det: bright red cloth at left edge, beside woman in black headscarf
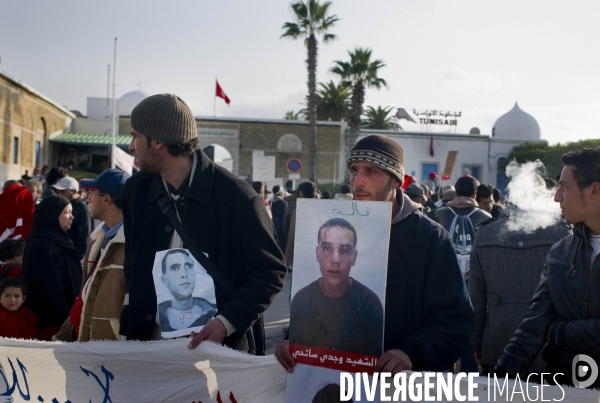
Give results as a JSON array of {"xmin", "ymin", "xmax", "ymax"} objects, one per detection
[{"xmin": 0, "ymin": 184, "xmax": 34, "ymax": 242}]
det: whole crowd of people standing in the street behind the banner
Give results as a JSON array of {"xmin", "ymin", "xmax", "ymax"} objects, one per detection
[{"xmin": 0, "ymin": 94, "xmax": 600, "ymax": 386}]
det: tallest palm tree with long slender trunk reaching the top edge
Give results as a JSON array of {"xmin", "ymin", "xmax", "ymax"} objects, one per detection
[{"xmin": 281, "ymin": 0, "xmax": 339, "ymax": 182}]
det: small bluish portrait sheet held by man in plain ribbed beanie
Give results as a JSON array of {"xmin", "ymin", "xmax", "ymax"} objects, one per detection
[{"xmin": 152, "ymin": 249, "xmax": 217, "ymax": 338}]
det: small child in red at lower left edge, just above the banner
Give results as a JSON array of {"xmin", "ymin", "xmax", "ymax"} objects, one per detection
[{"xmin": 0, "ymin": 277, "xmax": 39, "ymax": 339}]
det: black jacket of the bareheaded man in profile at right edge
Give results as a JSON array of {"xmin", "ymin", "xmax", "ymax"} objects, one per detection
[{"xmin": 498, "ymin": 223, "xmax": 600, "ymax": 379}]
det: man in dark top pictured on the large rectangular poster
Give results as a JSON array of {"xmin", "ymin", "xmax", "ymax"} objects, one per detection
[{"xmin": 290, "ymin": 218, "xmax": 383, "ymax": 356}]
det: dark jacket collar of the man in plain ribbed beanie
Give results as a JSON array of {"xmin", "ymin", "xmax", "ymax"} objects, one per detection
[{"xmin": 148, "ymin": 150, "xmax": 215, "ymax": 204}]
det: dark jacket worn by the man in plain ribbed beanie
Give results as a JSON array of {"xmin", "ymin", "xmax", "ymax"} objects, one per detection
[{"xmin": 120, "ymin": 151, "xmax": 286, "ymax": 354}]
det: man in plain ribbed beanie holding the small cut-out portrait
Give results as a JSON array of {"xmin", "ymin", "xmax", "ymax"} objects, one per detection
[{"xmin": 120, "ymin": 94, "xmax": 286, "ymax": 355}]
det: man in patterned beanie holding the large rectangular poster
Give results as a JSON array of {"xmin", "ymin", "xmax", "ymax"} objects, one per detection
[{"xmin": 275, "ymin": 134, "xmax": 474, "ymax": 374}]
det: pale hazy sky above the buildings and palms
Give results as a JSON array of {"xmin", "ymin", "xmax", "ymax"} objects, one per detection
[{"xmin": 0, "ymin": 0, "xmax": 600, "ymax": 144}]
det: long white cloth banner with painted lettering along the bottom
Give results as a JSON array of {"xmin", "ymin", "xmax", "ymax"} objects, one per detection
[{"xmin": 0, "ymin": 338, "xmax": 600, "ymax": 403}]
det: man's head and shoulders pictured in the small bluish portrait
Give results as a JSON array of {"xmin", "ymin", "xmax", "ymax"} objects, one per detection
[{"xmin": 158, "ymin": 249, "xmax": 217, "ymax": 332}]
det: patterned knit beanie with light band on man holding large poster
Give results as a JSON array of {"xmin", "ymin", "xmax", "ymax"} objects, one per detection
[{"xmin": 346, "ymin": 134, "xmax": 404, "ymax": 184}]
